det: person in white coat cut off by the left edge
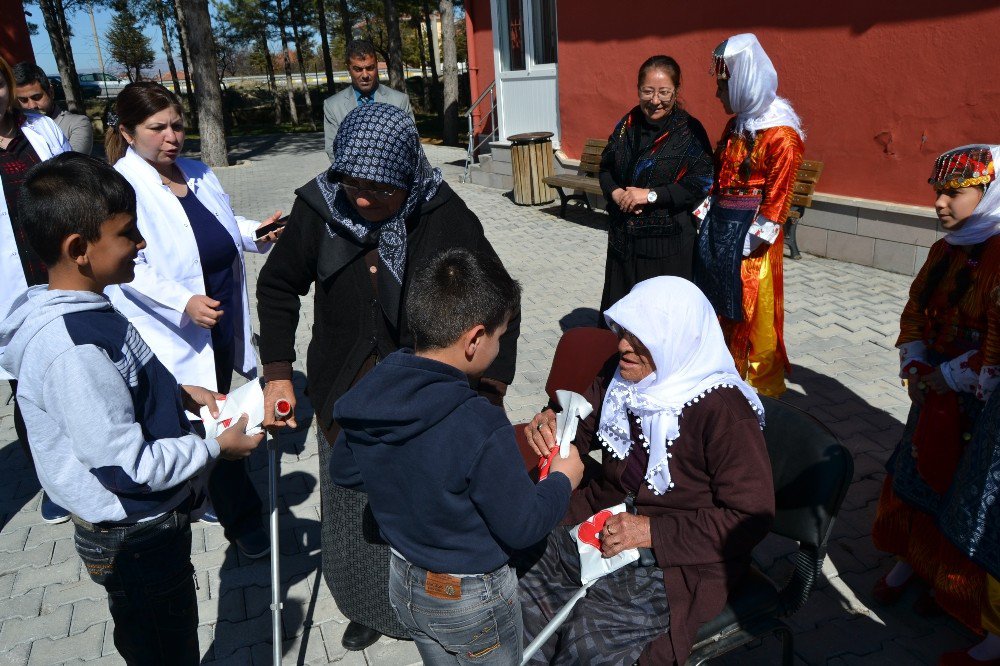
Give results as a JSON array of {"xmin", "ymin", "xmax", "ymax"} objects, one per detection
[{"xmin": 0, "ymin": 58, "xmax": 71, "ymax": 523}]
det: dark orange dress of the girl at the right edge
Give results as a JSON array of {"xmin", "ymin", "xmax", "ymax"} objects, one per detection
[{"xmin": 872, "ymin": 236, "xmax": 1000, "ymax": 632}]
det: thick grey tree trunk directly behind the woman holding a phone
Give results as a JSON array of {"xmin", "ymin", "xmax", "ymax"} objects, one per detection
[{"xmin": 179, "ymin": 0, "xmax": 229, "ymax": 167}]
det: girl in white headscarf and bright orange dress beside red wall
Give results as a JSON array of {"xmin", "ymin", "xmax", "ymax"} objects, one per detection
[{"xmin": 695, "ymin": 33, "xmax": 805, "ymax": 397}]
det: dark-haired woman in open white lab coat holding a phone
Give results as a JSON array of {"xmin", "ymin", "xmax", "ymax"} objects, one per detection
[{"xmin": 105, "ymin": 82, "xmax": 281, "ymax": 557}]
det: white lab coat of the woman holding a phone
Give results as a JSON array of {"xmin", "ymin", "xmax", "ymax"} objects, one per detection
[{"xmin": 106, "ymin": 148, "xmax": 270, "ymax": 390}]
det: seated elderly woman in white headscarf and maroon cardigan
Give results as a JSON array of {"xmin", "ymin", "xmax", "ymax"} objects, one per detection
[{"xmin": 520, "ymin": 277, "xmax": 774, "ymax": 664}]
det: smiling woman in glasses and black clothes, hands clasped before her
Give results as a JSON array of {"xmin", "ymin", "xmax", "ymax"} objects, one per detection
[{"xmin": 600, "ymin": 55, "xmax": 713, "ymax": 312}]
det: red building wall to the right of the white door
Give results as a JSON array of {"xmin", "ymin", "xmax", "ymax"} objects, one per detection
[{"xmin": 556, "ymin": 0, "xmax": 1000, "ymax": 205}]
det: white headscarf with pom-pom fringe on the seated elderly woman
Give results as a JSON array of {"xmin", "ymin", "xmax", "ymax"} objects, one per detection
[{"xmin": 597, "ymin": 277, "xmax": 764, "ymax": 494}]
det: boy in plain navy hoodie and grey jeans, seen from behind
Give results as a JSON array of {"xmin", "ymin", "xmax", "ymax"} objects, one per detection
[{"xmin": 330, "ymin": 249, "xmax": 583, "ymax": 664}]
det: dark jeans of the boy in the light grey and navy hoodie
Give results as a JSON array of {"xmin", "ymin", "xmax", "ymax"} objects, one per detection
[{"xmin": 74, "ymin": 509, "xmax": 201, "ymax": 666}]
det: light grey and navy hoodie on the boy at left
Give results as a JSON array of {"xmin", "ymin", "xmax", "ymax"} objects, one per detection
[{"xmin": 0, "ymin": 285, "xmax": 219, "ymax": 523}]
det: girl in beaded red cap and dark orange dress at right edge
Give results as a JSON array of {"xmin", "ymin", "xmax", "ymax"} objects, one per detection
[{"xmin": 872, "ymin": 145, "xmax": 1000, "ymax": 666}]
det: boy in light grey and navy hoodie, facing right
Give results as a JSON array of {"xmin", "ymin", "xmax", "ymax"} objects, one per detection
[{"xmin": 0, "ymin": 153, "xmax": 263, "ymax": 666}]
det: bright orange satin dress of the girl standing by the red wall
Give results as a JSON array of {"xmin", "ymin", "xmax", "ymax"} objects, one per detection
[{"xmin": 713, "ymin": 120, "xmax": 804, "ymax": 397}]
